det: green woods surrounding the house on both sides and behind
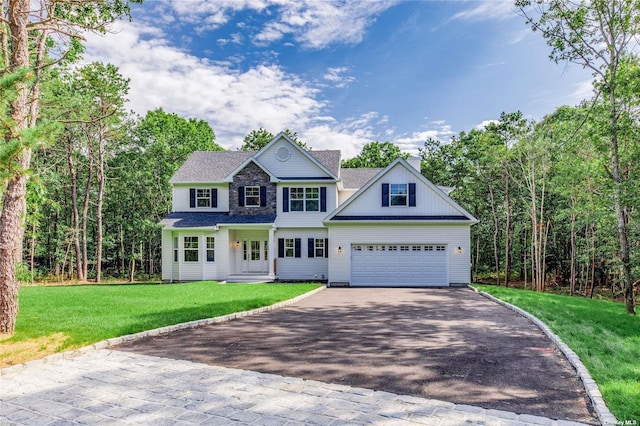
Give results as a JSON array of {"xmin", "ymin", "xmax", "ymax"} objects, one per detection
[{"xmin": 0, "ymin": 0, "xmax": 640, "ymax": 330}]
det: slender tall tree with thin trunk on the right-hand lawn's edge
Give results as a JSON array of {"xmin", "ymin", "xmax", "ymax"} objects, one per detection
[{"xmin": 516, "ymin": 0, "xmax": 640, "ymax": 314}]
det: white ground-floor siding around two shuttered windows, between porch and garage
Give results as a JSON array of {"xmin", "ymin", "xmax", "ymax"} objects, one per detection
[{"xmin": 274, "ymin": 229, "xmax": 331, "ymax": 281}]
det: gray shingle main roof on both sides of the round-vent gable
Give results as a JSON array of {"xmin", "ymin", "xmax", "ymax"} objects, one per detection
[{"xmin": 169, "ymin": 150, "xmax": 340, "ymax": 183}]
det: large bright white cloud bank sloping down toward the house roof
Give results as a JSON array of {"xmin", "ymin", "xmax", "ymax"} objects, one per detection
[{"xmin": 85, "ymin": 22, "xmax": 388, "ymax": 158}]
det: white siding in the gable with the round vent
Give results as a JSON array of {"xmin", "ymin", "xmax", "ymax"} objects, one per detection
[{"xmin": 257, "ymin": 139, "xmax": 331, "ymax": 178}]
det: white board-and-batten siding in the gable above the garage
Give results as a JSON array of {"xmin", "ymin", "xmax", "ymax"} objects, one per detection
[{"xmin": 340, "ymin": 164, "xmax": 460, "ymax": 216}]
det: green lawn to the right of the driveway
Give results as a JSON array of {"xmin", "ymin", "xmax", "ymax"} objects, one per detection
[{"xmin": 476, "ymin": 285, "xmax": 640, "ymax": 424}]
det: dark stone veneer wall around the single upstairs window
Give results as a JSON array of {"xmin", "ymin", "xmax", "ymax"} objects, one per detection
[{"xmin": 229, "ymin": 163, "xmax": 277, "ymax": 216}]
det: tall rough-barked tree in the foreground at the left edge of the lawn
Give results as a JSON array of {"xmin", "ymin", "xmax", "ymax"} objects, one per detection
[{"xmin": 0, "ymin": 0, "xmax": 140, "ymax": 334}]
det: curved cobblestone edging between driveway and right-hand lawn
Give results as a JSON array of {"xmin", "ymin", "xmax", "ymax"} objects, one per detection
[{"xmin": 469, "ymin": 285, "xmax": 619, "ymax": 425}]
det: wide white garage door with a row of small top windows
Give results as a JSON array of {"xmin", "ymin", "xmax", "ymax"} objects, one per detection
[{"xmin": 351, "ymin": 244, "xmax": 449, "ymax": 287}]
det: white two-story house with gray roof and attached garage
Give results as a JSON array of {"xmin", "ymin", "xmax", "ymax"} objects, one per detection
[{"xmin": 160, "ymin": 133, "xmax": 477, "ymax": 287}]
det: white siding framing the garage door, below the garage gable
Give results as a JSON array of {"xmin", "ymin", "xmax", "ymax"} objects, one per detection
[{"xmin": 328, "ymin": 223, "xmax": 471, "ymax": 284}]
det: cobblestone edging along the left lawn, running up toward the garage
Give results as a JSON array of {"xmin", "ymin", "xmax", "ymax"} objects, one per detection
[{"xmin": 0, "ymin": 286, "xmax": 326, "ymax": 377}]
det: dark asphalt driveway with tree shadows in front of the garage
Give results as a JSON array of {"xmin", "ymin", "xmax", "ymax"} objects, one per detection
[{"xmin": 116, "ymin": 288, "xmax": 597, "ymax": 423}]
